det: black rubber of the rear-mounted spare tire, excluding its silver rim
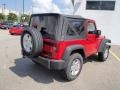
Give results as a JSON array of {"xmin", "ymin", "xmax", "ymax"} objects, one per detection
[{"xmin": 21, "ymin": 28, "xmax": 43, "ymax": 58}]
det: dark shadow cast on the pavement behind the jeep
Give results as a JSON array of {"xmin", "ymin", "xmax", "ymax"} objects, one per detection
[{"xmin": 10, "ymin": 58, "xmax": 66, "ymax": 84}]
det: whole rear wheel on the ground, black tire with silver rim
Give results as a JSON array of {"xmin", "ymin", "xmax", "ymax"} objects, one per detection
[{"xmin": 62, "ymin": 53, "xmax": 83, "ymax": 81}]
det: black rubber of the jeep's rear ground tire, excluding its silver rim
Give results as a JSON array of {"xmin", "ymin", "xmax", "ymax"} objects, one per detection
[{"xmin": 61, "ymin": 53, "xmax": 83, "ymax": 81}]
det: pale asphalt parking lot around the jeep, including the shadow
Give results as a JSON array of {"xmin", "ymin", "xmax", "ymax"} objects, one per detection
[{"xmin": 0, "ymin": 30, "xmax": 120, "ymax": 90}]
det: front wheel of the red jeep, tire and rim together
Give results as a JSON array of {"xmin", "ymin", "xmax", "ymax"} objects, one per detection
[{"xmin": 98, "ymin": 44, "xmax": 110, "ymax": 61}]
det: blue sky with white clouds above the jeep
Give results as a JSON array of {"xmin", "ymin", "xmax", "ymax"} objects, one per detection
[{"xmin": 0, "ymin": 0, "xmax": 73, "ymax": 14}]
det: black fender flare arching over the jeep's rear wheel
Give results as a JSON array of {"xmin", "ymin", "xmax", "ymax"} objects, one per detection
[{"xmin": 62, "ymin": 45, "xmax": 86, "ymax": 61}]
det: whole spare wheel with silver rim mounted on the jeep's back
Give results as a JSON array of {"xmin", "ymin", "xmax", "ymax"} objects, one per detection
[{"xmin": 21, "ymin": 28, "xmax": 43, "ymax": 58}]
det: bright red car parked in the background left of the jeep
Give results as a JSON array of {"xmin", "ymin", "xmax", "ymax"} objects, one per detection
[{"xmin": 9, "ymin": 25, "xmax": 27, "ymax": 35}]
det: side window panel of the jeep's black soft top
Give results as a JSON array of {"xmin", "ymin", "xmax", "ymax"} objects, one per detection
[{"xmin": 65, "ymin": 19, "xmax": 86, "ymax": 40}]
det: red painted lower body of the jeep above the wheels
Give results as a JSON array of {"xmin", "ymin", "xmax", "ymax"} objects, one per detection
[{"xmin": 43, "ymin": 37, "xmax": 104, "ymax": 60}]
